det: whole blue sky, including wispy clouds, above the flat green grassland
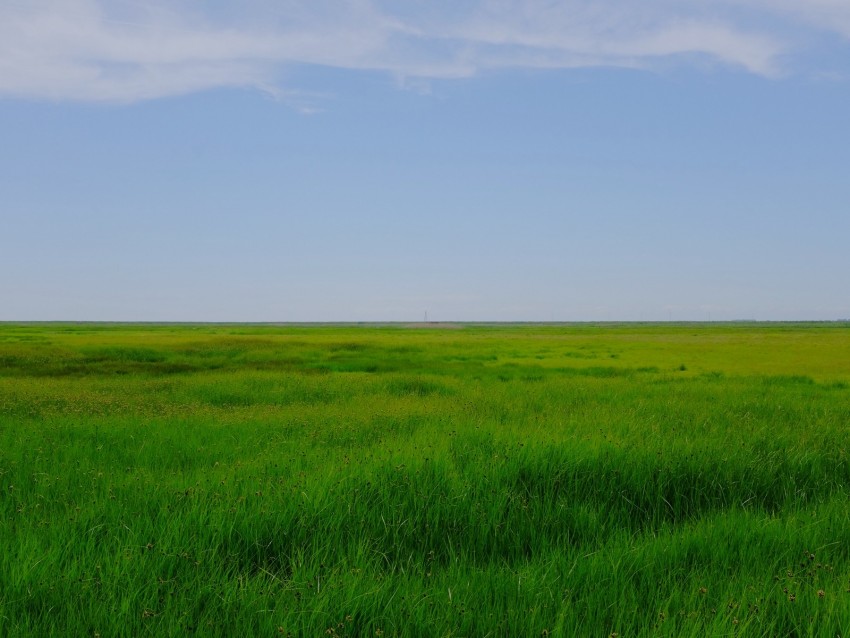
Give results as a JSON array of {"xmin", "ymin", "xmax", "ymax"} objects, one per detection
[{"xmin": 0, "ymin": 0, "xmax": 850, "ymax": 322}]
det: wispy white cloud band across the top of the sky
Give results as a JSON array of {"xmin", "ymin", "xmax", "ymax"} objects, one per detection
[{"xmin": 0, "ymin": 0, "xmax": 850, "ymax": 102}]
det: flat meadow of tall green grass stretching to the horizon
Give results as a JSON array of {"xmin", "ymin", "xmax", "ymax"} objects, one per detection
[{"xmin": 0, "ymin": 324, "xmax": 850, "ymax": 638}]
